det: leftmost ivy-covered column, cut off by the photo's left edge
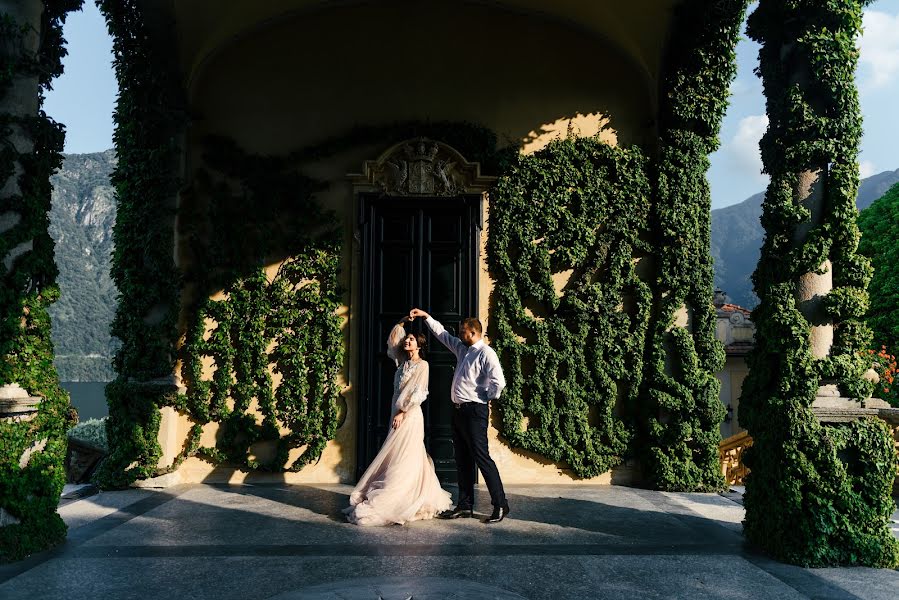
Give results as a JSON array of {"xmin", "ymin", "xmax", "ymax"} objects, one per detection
[{"xmin": 0, "ymin": 0, "xmax": 81, "ymax": 560}]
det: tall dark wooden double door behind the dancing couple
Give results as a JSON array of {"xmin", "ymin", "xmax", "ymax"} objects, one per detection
[{"xmin": 356, "ymin": 195, "xmax": 481, "ymax": 483}]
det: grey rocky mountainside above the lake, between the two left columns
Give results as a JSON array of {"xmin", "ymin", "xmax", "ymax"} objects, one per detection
[{"xmin": 50, "ymin": 150, "xmax": 117, "ymax": 381}]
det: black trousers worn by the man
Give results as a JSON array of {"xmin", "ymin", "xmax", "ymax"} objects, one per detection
[{"xmin": 453, "ymin": 402, "xmax": 507, "ymax": 508}]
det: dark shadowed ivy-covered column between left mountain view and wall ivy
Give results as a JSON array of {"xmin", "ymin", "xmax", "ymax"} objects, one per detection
[{"xmin": 96, "ymin": 0, "xmax": 182, "ymax": 487}]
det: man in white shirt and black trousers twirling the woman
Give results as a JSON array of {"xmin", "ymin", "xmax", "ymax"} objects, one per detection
[{"xmin": 409, "ymin": 308, "xmax": 509, "ymax": 523}]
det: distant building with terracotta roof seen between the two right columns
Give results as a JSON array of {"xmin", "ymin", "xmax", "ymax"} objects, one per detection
[{"xmin": 713, "ymin": 290, "xmax": 755, "ymax": 438}]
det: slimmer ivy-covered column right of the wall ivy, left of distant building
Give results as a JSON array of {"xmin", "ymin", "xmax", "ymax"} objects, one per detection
[{"xmin": 641, "ymin": 0, "xmax": 747, "ymax": 491}]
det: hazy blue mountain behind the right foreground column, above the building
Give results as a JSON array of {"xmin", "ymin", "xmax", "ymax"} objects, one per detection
[{"xmin": 712, "ymin": 169, "xmax": 899, "ymax": 309}]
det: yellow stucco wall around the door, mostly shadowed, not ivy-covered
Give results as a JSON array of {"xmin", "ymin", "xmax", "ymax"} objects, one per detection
[{"xmin": 160, "ymin": 3, "xmax": 655, "ymax": 483}]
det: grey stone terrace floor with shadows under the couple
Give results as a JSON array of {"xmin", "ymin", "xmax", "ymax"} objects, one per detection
[{"xmin": 0, "ymin": 484, "xmax": 899, "ymax": 600}]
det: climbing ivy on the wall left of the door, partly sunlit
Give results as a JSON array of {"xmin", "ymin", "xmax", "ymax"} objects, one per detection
[{"xmin": 171, "ymin": 139, "xmax": 343, "ymax": 471}]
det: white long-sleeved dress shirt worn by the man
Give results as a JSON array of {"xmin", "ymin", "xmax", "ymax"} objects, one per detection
[{"xmin": 425, "ymin": 317, "xmax": 506, "ymax": 404}]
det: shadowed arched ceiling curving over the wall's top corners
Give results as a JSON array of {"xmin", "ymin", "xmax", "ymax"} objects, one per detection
[{"xmin": 155, "ymin": 0, "xmax": 680, "ymax": 89}]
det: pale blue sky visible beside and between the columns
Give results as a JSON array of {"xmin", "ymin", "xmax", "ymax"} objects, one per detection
[{"xmin": 44, "ymin": 0, "xmax": 899, "ymax": 208}]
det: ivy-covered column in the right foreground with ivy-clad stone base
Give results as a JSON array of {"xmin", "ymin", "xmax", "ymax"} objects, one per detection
[{"xmin": 740, "ymin": 0, "xmax": 899, "ymax": 567}]
